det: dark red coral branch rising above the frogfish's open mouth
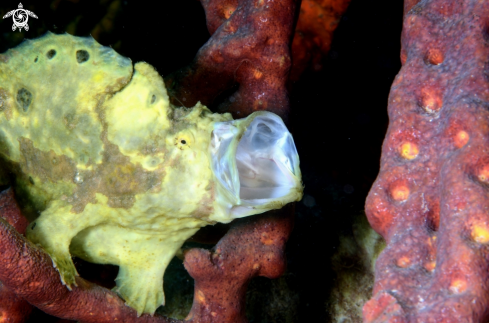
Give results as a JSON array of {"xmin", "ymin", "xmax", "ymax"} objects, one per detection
[{"xmin": 165, "ymin": 0, "xmax": 298, "ymax": 118}]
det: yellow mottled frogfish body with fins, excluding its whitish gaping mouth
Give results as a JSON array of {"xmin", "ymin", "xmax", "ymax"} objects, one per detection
[{"xmin": 0, "ymin": 33, "xmax": 302, "ymax": 314}]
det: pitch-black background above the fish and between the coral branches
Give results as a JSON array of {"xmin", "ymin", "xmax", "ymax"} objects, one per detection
[{"xmin": 0, "ymin": 0, "xmax": 403, "ymax": 322}]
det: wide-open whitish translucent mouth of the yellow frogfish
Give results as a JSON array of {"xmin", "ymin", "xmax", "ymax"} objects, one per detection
[{"xmin": 209, "ymin": 111, "xmax": 303, "ymax": 218}]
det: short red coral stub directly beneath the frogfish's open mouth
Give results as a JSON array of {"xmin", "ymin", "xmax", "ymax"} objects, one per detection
[{"xmin": 184, "ymin": 205, "xmax": 294, "ymax": 323}]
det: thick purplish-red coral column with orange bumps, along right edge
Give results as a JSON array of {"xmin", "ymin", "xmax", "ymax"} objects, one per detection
[{"xmin": 363, "ymin": 0, "xmax": 489, "ymax": 322}]
